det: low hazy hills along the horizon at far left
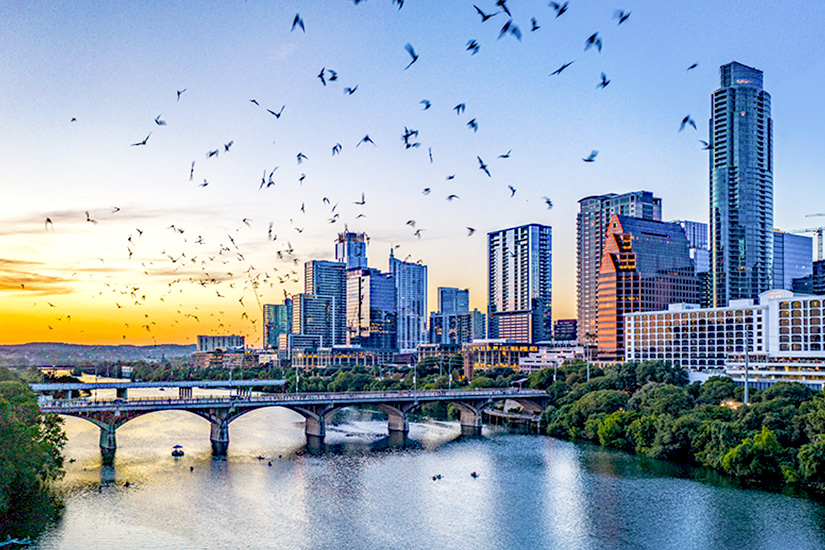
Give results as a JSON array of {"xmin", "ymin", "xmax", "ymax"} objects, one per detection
[{"xmin": 0, "ymin": 342, "xmax": 197, "ymax": 366}]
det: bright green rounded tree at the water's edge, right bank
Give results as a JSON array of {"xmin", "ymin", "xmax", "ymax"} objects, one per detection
[{"xmin": 722, "ymin": 426, "xmax": 783, "ymax": 481}]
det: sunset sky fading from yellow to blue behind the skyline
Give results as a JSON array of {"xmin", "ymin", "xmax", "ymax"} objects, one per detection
[{"xmin": 0, "ymin": 0, "xmax": 825, "ymax": 345}]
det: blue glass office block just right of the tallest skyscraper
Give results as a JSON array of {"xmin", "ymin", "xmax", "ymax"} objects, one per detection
[{"xmin": 773, "ymin": 230, "xmax": 814, "ymax": 294}]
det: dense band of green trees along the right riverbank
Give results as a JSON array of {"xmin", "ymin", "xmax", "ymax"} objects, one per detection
[{"xmin": 530, "ymin": 361, "xmax": 825, "ymax": 494}]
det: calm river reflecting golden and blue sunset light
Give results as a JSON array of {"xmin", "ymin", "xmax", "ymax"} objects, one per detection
[{"xmin": 20, "ymin": 390, "xmax": 825, "ymax": 550}]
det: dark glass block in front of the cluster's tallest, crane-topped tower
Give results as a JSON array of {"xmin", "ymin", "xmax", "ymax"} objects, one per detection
[{"xmin": 347, "ymin": 268, "xmax": 397, "ymax": 351}]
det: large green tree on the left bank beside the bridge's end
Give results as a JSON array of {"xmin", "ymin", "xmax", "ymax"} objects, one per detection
[{"xmin": 0, "ymin": 381, "xmax": 66, "ymax": 513}]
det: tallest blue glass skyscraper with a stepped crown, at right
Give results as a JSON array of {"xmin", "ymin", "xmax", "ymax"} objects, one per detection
[{"xmin": 709, "ymin": 61, "xmax": 773, "ymax": 307}]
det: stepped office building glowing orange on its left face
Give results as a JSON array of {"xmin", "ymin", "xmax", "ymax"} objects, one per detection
[{"xmin": 596, "ymin": 215, "xmax": 700, "ymax": 362}]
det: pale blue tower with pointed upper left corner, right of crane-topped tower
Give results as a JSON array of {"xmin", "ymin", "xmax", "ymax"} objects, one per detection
[{"xmin": 389, "ymin": 249, "xmax": 427, "ymax": 353}]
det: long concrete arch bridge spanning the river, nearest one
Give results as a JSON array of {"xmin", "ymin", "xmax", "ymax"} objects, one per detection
[{"xmin": 33, "ymin": 381, "xmax": 548, "ymax": 463}]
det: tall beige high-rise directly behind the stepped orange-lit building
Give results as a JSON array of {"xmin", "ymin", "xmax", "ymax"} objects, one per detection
[{"xmin": 576, "ymin": 191, "xmax": 662, "ymax": 343}]
